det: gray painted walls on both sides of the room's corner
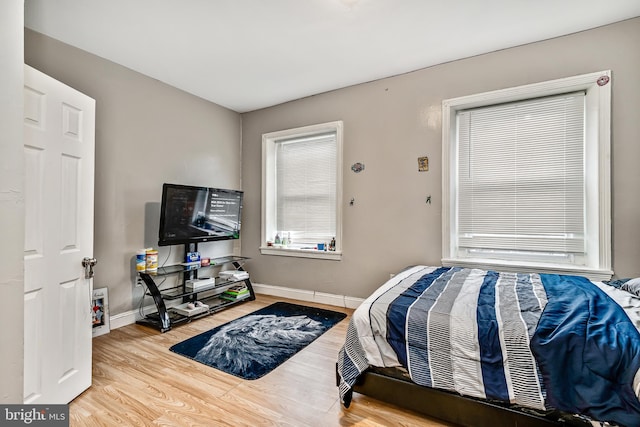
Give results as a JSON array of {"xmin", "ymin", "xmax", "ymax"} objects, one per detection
[{"xmin": 25, "ymin": 18, "xmax": 640, "ymax": 314}]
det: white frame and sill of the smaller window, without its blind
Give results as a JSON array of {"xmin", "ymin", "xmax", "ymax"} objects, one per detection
[{"xmin": 260, "ymin": 121, "xmax": 344, "ymax": 260}]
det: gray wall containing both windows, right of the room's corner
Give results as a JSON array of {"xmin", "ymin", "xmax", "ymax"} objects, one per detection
[{"xmin": 242, "ymin": 18, "xmax": 640, "ymax": 297}]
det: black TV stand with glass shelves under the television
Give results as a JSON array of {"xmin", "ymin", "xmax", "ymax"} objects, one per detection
[{"xmin": 136, "ymin": 247, "xmax": 256, "ymax": 332}]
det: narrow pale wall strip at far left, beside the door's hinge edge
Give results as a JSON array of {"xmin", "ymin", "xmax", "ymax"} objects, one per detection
[{"xmin": 0, "ymin": 0, "xmax": 24, "ymax": 404}]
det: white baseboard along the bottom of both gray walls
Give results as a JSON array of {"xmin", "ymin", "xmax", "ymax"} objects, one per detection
[{"xmin": 109, "ymin": 283, "xmax": 364, "ymax": 329}]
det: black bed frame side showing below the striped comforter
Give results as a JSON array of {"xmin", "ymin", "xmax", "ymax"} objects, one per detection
[{"xmin": 342, "ymin": 371, "xmax": 591, "ymax": 427}]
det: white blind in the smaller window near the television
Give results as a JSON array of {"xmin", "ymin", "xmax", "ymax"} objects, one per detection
[{"xmin": 275, "ymin": 132, "xmax": 337, "ymax": 244}]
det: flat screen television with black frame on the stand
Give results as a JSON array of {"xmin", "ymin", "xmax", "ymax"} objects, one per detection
[{"xmin": 158, "ymin": 183, "xmax": 243, "ymax": 246}]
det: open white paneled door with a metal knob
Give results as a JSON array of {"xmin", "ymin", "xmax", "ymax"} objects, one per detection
[{"xmin": 24, "ymin": 65, "xmax": 95, "ymax": 404}]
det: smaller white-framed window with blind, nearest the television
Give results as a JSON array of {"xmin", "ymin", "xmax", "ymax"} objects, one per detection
[{"xmin": 260, "ymin": 121, "xmax": 342, "ymax": 259}]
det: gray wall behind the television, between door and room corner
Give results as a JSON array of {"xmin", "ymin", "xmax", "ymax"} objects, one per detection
[{"xmin": 25, "ymin": 29, "xmax": 241, "ymax": 316}]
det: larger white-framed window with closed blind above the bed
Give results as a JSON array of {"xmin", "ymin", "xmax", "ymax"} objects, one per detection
[{"xmin": 443, "ymin": 71, "xmax": 612, "ymax": 280}]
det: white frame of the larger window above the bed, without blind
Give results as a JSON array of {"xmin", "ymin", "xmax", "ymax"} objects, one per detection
[{"xmin": 442, "ymin": 70, "xmax": 613, "ymax": 280}]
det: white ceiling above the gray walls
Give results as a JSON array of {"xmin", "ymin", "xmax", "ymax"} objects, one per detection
[{"xmin": 25, "ymin": 0, "xmax": 640, "ymax": 112}]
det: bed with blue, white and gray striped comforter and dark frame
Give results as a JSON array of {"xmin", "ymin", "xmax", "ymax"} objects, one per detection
[{"xmin": 337, "ymin": 266, "xmax": 640, "ymax": 427}]
